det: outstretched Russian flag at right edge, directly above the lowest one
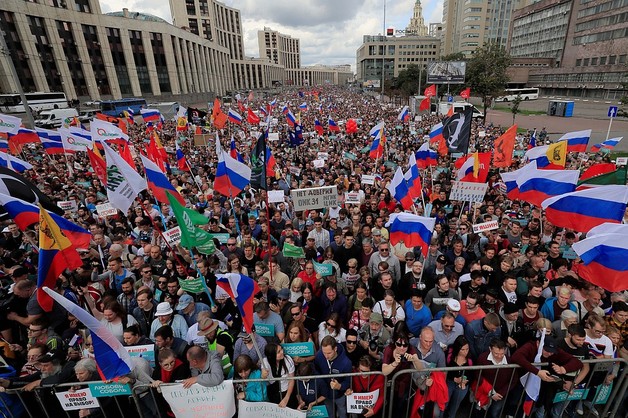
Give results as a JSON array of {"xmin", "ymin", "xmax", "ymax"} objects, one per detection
[{"xmin": 542, "ymin": 185, "xmax": 628, "ymax": 232}]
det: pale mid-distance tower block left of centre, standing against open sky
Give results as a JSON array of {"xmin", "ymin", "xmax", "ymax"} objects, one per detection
[{"xmin": 257, "ymin": 27, "xmax": 301, "ymax": 69}]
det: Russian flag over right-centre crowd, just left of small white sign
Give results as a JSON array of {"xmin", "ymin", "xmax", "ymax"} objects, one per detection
[{"xmin": 386, "ymin": 213, "xmax": 436, "ymax": 257}]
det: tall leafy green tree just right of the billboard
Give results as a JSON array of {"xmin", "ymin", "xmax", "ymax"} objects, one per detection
[{"xmin": 466, "ymin": 43, "xmax": 512, "ymax": 119}]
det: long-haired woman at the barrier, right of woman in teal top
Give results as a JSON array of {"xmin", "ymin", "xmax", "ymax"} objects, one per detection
[{"xmin": 262, "ymin": 343, "xmax": 297, "ymax": 408}]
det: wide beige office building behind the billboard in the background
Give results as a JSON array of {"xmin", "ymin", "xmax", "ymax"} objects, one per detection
[{"xmin": 356, "ymin": 35, "xmax": 440, "ymax": 83}]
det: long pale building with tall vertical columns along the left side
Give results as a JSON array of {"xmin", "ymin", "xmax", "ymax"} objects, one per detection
[{"xmin": 0, "ymin": 0, "xmax": 354, "ymax": 103}]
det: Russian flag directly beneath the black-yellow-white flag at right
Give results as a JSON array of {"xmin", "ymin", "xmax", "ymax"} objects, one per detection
[{"xmin": 506, "ymin": 161, "xmax": 580, "ymax": 207}]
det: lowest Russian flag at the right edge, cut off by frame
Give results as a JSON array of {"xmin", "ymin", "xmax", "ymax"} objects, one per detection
[{"xmin": 572, "ymin": 230, "xmax": 628, "ymax": 292}]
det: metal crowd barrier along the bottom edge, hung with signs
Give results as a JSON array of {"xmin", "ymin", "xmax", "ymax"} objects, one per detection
[{"xmin": 0, "ymin": 359, "xmax": 628, "ymax": 418}]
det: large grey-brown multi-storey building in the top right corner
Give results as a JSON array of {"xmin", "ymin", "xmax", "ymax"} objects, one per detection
[{"xmin": 510, "ymin": 0, "xmax": 628, "ymax": 100}]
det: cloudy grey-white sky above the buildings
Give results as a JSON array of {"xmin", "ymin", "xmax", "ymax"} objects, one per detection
[{"xmin": 100, "ymin": 0, "xmax": 443, "ymax": 68}]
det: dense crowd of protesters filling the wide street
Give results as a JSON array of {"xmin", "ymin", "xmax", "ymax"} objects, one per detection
[{"xmin": 0, "ymin": 87, "xmax": 628, "ymax": 418}]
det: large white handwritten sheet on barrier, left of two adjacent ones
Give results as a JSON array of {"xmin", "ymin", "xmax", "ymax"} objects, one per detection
[{"xmin": 160, "ymin": 380, "xmax": 235, "ymax": 418}]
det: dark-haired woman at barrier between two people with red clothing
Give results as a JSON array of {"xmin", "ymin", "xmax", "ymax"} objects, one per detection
[{"xmin": 445, "ymin": 335, "xmax": 473, "ymax": 418}]
